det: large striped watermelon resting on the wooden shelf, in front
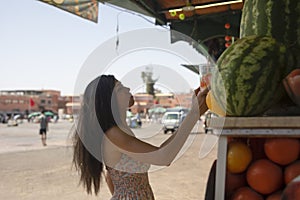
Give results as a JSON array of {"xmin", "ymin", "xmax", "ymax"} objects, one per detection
[{"xmin": 211, "ymin": 35, "xmax": 293, "ymax": 116}]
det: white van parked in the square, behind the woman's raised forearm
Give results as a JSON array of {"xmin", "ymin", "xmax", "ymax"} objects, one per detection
[{"xmin": 161, "ymin": 112, "xmax": 184, "ymax": 134}]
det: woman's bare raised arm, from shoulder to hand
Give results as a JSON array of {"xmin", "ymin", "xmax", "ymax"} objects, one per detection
[{"xmin": 105, "ymin": 89, "xmax": 208, "ymax": 166}]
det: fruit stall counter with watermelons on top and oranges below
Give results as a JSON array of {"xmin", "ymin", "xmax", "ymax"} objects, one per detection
[{"xmin": 207, "ymin": 0, "xmax": 300, "ymax": 200}]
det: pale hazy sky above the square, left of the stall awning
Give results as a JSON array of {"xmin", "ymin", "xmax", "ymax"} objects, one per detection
[{"xmin": 0, "ymin": 0, "xmax": 207, "ymax": 95}]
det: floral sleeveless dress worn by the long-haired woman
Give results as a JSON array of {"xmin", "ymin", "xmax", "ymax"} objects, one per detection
[{"xmin": 106, "ymin": 154, "xmax": 154, "ymax": 200}]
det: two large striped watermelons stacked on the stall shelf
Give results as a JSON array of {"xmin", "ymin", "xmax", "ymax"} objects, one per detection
[{"xmin": 211, "ymin": 0, "xmax": 300, "ymax": 116}]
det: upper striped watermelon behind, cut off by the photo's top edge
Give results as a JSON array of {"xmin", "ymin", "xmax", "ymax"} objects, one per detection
[{"xmin": 240, "ymin": 0, "xmax": 300, "ymax": 68}]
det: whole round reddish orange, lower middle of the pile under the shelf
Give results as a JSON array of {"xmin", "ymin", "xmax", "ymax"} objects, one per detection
[{"xmin": 247, "ymin": 159, "xmax": 283, "ymax": 194}]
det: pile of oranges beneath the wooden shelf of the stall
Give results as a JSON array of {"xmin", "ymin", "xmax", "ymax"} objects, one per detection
[{"xmin": 225, "ymin": 138, "xmax": 300, "ymax": 200}]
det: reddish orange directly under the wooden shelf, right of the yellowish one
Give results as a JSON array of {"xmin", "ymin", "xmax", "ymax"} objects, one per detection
[{"xmin": 264, "ymin": 138, "xmax": 300, "ymax": 165}]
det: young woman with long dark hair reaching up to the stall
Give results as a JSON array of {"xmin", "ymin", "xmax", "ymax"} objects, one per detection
[{"xmin": 73, "ymin": 75, "xmax": 208, "ymax": 200}]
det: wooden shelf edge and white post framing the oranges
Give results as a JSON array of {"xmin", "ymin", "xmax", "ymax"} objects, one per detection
[{"xmin": 209, "ymin": 116, "xmax": 300, "ymax": 200}]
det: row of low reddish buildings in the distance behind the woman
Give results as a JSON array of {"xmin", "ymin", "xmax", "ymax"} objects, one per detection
[{"xmin": 0, "ymin": 90, "xmax": 192, "ymax": 115}]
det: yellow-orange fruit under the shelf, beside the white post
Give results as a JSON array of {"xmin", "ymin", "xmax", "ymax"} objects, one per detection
[{"xmin": 227, "ymin": 141, "xmax": 252, "ymax": 173}]
